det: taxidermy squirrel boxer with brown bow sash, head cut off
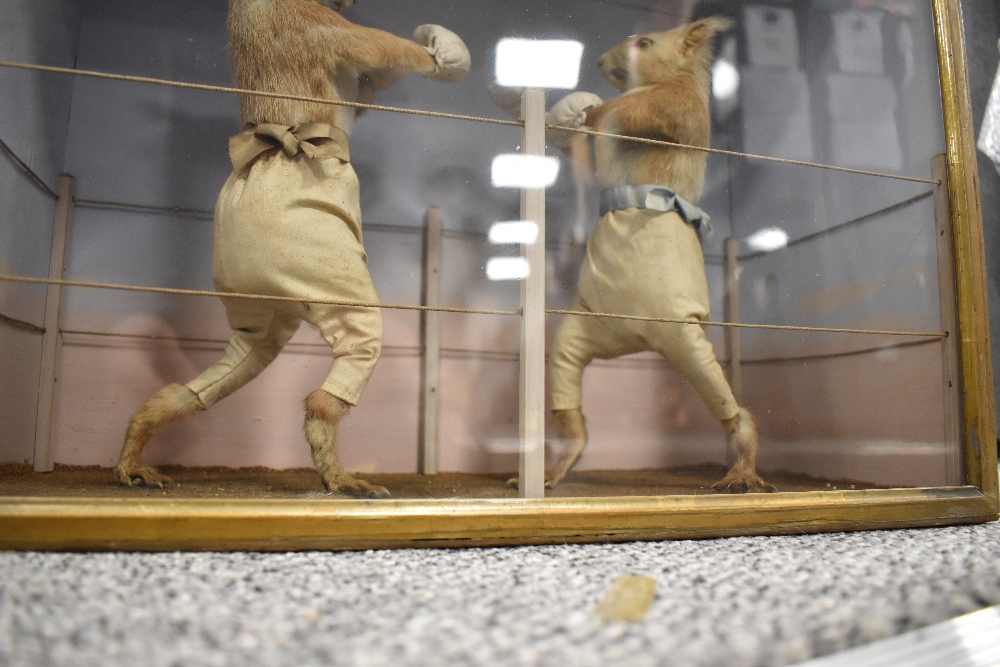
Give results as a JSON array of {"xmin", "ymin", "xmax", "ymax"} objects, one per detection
[{"xmin": 116, "ymin": 0, "xmax": 470, "ymax": 498}]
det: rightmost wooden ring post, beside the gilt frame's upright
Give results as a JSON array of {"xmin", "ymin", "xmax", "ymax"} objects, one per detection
[{"xmin": 931, "ymin": 153, "xmax": 964, "ymax": 485}]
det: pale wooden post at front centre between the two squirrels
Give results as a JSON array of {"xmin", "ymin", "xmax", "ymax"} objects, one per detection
[{"xmin": 518, "ymin": 88, "xmax": 545, "ymax": 498}]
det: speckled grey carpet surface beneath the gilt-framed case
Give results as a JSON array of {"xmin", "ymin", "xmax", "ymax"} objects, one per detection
[{"xmin": 0, "ymin": 524, "xmax": 1000, "ymax": 667}]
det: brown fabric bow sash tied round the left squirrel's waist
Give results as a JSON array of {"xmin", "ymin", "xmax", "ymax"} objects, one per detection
[{"xmin": 229, "ymin": 123, "xmax": 351, "ymax": 173}]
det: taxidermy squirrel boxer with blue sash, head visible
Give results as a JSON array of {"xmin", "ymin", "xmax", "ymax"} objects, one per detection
[{"xmin": 493, "ymin": 17, "xmax": 774, "ymax": 493}]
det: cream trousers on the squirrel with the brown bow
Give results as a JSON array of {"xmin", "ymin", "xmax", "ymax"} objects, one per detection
[{"xmin": 187, "ymin": 150, "xmax": 382, "ymax": 408}]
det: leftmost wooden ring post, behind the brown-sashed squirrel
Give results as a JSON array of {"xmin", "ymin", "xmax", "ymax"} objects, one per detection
[{"xmin": 35, "ymin": 174, "xmax": 76, "ymax": 472}]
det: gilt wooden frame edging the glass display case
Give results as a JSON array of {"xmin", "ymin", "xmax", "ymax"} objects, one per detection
[{"xmin": 0, "ymin": 0, "xmax": 1000, "ymax": 551}]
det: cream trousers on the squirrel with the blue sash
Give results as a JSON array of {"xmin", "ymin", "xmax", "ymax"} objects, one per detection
[{"xmin": 549, "ymin": 208, "xmax": 739, "ymax": 420}]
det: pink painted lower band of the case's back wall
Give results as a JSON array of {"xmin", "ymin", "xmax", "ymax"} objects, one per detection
[{"xmin": 0, "ymin": 299, "xmax": 946, "ymax": 486}]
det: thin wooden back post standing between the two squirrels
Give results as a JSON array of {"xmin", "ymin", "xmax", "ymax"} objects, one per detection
[{"xmin": 417, "ymin": 206, "xmax": 441, "ymax": 475}]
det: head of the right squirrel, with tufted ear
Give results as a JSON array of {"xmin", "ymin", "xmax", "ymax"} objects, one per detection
[{"xmin": 597, "ymin": 16, "xmax": 732, "ymax": 92}]
